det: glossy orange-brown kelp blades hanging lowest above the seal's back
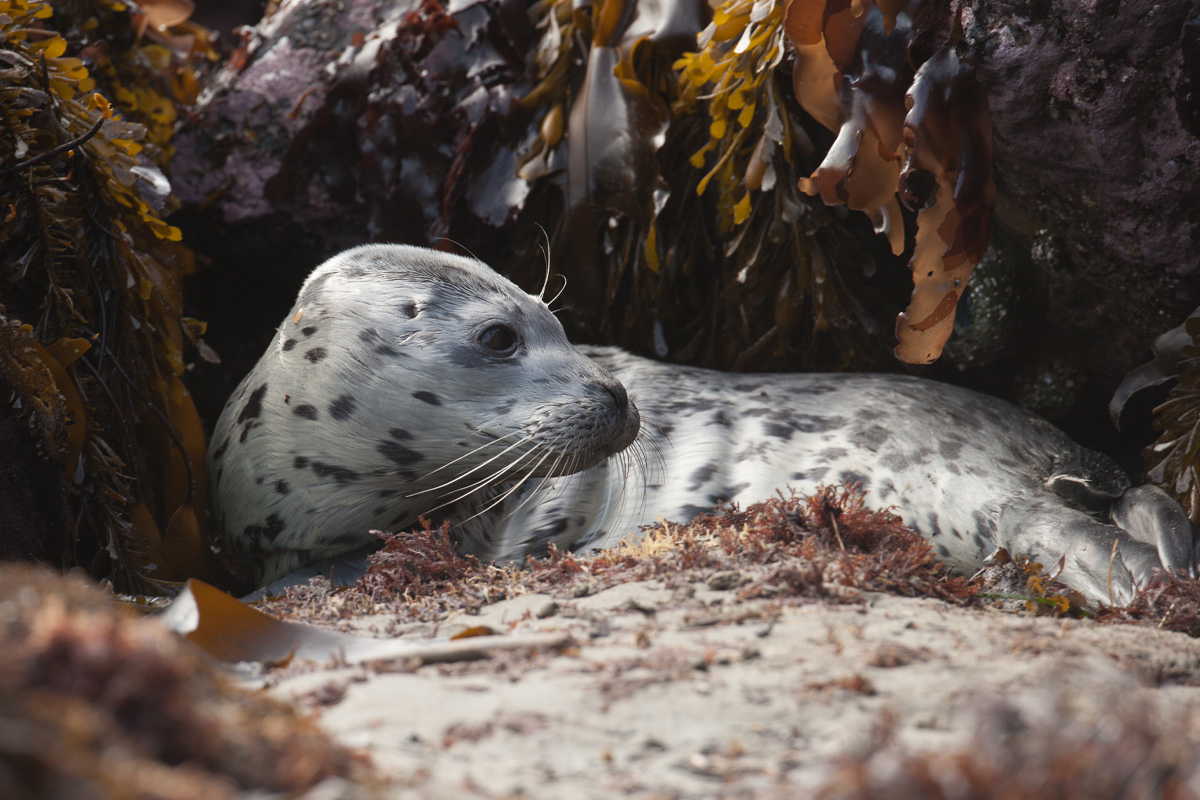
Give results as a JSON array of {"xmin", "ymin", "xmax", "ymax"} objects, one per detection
[{"xmin": 784, "ymin": 0, "xmax": 995, "ymax": 363}]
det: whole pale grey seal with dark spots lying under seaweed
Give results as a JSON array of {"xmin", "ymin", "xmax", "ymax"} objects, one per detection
[{"xmin": 209, "ymin": 245, "xmax": 1198, "ymax": 602}]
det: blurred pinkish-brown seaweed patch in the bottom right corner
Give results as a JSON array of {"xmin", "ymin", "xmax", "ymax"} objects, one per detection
[{"xmin": 814, "ymin": 696, "xmax": 1200, "ymax": 800}]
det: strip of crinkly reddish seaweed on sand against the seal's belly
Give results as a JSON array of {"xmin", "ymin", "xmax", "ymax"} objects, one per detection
[{"xmin": 270, "ymin": 487, "xmax": 972, "ymax": 621}]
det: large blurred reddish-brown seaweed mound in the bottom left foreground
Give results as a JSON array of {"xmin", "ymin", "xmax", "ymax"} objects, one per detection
[{"xmin": 0, "ymin": 565, "xmax": 370, "ymax": 800}]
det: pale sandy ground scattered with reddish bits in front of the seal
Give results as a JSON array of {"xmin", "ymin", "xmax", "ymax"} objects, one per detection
[{"xmin": 270, "ymin": 582, "xmax": 1200, "ymax": 798}]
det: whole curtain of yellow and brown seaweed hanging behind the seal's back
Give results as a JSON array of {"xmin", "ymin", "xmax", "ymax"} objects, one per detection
[{"xmin": 522, "ymin": 0, "xmax": 995, "ymax": 369}]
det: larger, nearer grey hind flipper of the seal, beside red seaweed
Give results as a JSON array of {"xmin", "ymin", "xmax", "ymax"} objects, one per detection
[{"xmin": 996, "ymin": 498, "xmax": 1162, "ymax": 606}]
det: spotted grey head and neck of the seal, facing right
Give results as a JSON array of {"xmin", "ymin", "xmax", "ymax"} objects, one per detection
[{"xmin": 209, "ymin": 245, "xmax": 640, "ymax": 582}]
